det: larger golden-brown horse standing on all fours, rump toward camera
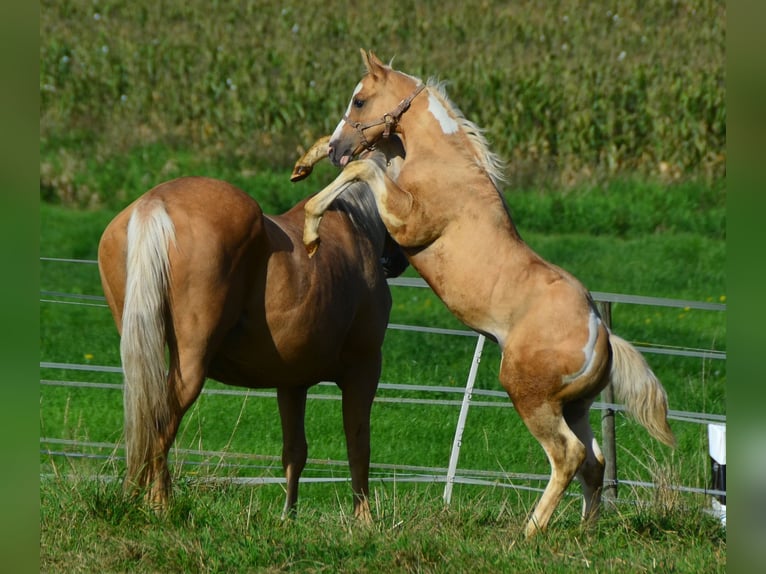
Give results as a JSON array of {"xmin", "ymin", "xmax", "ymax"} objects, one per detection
[{"xmin": 98, "ymin": 172, "xmax": 407, "ymax": 521}]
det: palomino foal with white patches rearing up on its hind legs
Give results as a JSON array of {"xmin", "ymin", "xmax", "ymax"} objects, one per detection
[{"xmin": 304, "ymin": 51, "xmax": 675, "ymax": 536}]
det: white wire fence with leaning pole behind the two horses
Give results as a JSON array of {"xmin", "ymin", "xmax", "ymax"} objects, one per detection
[{"xmin": 40, "ymin": 257, "xmax": 726, "ymax": 501}]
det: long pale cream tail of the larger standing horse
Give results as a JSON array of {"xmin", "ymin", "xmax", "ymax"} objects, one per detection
[{"xmin": 120, "ymin": 201, "xmax": 175, "ymax": 486}]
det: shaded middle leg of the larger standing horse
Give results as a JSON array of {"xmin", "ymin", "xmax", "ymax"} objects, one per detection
[{"xmin": 277, "ymin": 387, "xmax": 308, "ymax": 519}]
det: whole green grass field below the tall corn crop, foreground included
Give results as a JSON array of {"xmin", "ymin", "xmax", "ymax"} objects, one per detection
[{"xmin": 40, "ymin": 179, "xmax": 726, "ymax": 572}]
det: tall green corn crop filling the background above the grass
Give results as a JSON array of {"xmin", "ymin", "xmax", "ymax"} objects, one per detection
[{"xmin": 40, "ymin": 0, "xmax": 726, "ymax": 205}]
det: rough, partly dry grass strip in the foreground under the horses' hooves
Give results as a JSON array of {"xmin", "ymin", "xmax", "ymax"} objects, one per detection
[{"xmin": 41, "ymin": 472, "xmax": 726, "ymax": 573}]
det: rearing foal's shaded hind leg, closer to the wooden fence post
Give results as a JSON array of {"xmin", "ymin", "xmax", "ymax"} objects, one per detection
[{"xmin": 564, "ymin": 400, "xmax": 604, "ymax": 521}]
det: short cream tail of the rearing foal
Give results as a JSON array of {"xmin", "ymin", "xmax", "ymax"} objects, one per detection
[{"xmin": 609, "ymin": 333, "xmax": 676, "ymax": 447}]
